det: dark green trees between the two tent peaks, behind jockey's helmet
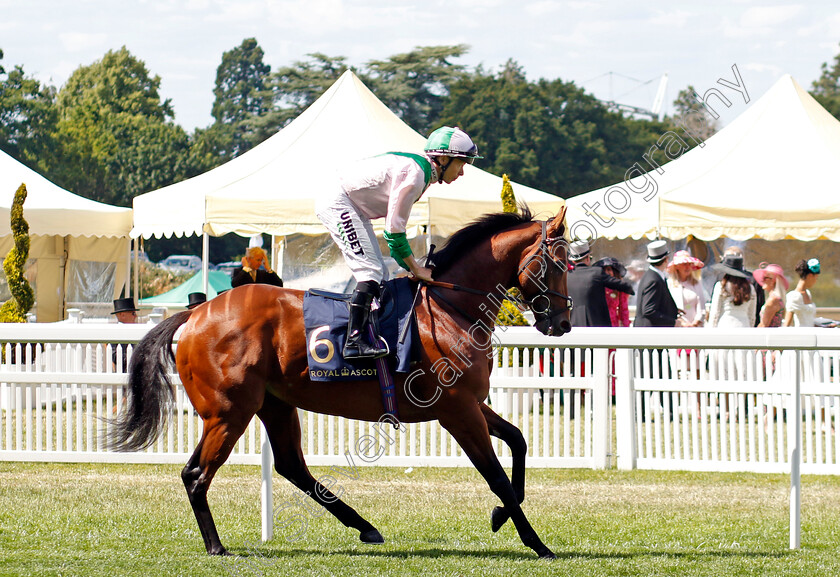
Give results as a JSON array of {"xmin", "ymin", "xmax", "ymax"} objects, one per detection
[{"xmin": 440, "ymin": 61, "xmax": 662, "ymax": 198}]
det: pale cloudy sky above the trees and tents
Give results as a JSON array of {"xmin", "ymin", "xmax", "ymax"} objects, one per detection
[{"xmin": 0, "ymin": 0, "xmax": 840, "ymax": 131}]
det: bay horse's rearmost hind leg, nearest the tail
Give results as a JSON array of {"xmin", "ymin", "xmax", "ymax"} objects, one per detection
[{"xmin": 181, "ymin": 414, "xmax": 253, "ymax": 555}]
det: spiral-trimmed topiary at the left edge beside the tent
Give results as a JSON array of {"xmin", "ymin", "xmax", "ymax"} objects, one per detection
[{"xmin": 0, "ymin": 184, "xmax": 35, "ymax": 323}]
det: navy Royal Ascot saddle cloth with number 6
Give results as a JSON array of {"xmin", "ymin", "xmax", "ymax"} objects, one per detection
[{"xmin": 303, "ymin": 277, "xmax": 420, "ymax": 381}]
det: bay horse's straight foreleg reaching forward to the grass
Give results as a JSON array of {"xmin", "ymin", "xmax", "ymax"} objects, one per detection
[{"xmin": 440, "ymin": 403, "xmax": 555, "ymax": 559}]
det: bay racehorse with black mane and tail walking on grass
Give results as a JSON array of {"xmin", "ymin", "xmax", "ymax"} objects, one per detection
[{"xmin": 108, "ymin": 205, "xmax": 571, "ymax": 558}]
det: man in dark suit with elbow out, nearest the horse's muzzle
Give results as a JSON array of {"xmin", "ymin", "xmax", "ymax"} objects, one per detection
[{"xmin": 566, "ymin": 240, "xmax": 633, "ymax": 327}]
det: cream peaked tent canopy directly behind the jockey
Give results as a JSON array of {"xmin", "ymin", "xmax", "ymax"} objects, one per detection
[{"xmin": 132, "ymin": 71, "xmax": 563, "ymax": 238}]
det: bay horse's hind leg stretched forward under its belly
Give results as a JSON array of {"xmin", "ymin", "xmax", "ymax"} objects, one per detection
[{"xmin": 257, "ymin": 394, "xmax": 385, "ymax": 543}]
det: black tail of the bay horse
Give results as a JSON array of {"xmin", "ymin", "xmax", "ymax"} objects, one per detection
[{"xmin": 105, "ymin": 311, "xmax": 192, "ymax": 451}]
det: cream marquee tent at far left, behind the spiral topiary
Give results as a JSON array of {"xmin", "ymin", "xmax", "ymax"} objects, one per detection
[{"xmin": 0, "ymin": 151, "xmax": 131, "ymax": 322}]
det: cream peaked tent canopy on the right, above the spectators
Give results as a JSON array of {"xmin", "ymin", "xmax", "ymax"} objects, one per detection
[{"xmin": 568, "ymin": 75, "xmax": 840, "ymax": 241}]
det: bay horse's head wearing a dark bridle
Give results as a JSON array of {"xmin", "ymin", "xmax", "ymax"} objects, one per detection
[{"xmin": 519, "ymin": 207, "xmax": 573, "ymax": 336}]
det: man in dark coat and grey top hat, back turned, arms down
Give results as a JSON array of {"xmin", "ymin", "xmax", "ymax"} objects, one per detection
[{"xmin": 633, "ymin": 240, "xmax": 678, "ymax": 327}]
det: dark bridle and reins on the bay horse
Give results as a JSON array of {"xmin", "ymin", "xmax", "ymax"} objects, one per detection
[{"xmin": 418, "ymin": 220, "xmax": 574, "ymax": 327}]
